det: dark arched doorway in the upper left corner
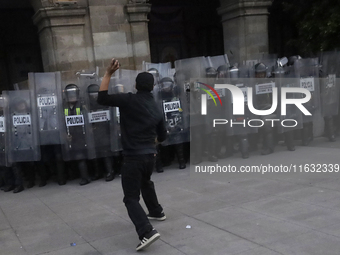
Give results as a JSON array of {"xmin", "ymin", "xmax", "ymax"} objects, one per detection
[{"xmin": 0, "ymin": 0, "xmax": 43, "ymax": 91}]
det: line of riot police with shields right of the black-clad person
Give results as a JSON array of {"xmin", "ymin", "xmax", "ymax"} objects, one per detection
[{"xmin": 144, "ymin": 52, "xmax": 340, "ymax": 165}]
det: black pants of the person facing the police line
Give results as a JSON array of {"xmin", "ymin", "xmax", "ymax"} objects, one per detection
[{"xmin": 121, "ymin": 154, "xmax": 163, "ymax": 239}]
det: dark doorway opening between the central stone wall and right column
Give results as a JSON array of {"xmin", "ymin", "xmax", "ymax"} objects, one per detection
[{"xmin": 149, "ymin": 0, "xmax": 224, "ymax": 64}]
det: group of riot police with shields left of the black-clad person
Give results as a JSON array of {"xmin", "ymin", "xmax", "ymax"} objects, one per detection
[{"xmin": 0, "ymin": 71, "xmax": 129, "ymax": 193}]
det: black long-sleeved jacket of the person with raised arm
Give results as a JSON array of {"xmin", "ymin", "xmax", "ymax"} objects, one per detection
[{"xmin": 97, "ymin": 91, "xmax": 166, "ymax": 155}]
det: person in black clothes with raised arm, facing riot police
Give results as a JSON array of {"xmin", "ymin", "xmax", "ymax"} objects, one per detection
[{"xmin": 97, "ymin": 59, "xmax": 166, "ymax": 251}]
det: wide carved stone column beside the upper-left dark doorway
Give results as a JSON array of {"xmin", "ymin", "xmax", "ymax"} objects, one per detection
[{"xmin": 33, "ymin": 6, "xmax": 90, "ymax": 72}]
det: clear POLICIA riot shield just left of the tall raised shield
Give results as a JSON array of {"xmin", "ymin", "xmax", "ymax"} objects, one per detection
[{"xmin": 3, "ymin": 90, "xmax": 40, "ymax": 163}]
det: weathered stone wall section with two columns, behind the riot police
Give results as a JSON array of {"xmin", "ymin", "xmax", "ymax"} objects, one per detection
[{"xmin": 31, "ymin": 0, "xmax": 150, "ymax": 75}]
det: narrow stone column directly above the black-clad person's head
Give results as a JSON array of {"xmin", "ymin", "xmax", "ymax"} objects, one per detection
[{"xmin": 126, "ymin": 1, "xmax": 151, "ymax": 70}]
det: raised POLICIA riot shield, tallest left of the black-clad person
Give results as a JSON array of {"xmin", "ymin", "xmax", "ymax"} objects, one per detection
[{"xmin": 28, "ymin": 72, "xmax": 62, "ymax": 145}]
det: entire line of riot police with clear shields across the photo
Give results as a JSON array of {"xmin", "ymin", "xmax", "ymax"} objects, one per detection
[{"xmin": 0, "ymin": 52, "xmax": 340, "ymax": 192}]
